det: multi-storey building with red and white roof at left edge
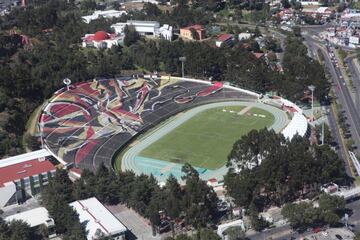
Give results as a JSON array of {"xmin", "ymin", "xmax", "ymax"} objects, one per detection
[{"xmin": 0, "ymin": 149, "xmax": 56, "ymax": 208}]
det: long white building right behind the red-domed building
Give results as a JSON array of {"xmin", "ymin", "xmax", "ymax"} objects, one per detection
[{"xmin": 111, "ymin": 20, "xmax": 173, "ymax": 41}]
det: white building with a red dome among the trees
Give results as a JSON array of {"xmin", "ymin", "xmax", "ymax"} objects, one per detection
[{"xmin": 82, "ymin": 31, "xmax": 124, "ymax": 48}]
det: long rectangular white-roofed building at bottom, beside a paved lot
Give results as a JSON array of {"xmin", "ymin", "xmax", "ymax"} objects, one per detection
[{"xmin": 70, "ymin": 197, "xmax": 127, "ymax": 240}]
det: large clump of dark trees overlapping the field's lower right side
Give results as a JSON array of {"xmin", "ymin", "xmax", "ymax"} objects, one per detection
[{"xmin": 224, "ymin": 129, "xmax": 346, "ymax": 209}]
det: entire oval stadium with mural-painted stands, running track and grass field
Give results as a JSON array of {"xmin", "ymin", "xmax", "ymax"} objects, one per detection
[{"xmin": 39, "ymin": 75, "xmax": 309, "ymax": 182}]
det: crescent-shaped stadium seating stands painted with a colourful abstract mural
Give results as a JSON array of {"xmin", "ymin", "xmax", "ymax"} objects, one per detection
[{"xmin": 39, "ymin": 75, "xmax": 308, "ymax": 179}]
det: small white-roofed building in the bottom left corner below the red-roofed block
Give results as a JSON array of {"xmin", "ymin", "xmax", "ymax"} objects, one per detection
[{"xmin": 5, "ymin": 207, "xmax": 56, "ymax": 239}]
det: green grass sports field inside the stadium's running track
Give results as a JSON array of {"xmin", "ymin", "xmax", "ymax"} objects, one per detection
[{"xmin": 140, "ymin": 106, "xmax": 274, "ymax": 170}]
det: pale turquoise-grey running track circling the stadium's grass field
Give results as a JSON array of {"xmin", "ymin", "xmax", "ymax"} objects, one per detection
[{"xmin": 121, "ymin": 101, "xmax": 289, "ymax": 182}]
